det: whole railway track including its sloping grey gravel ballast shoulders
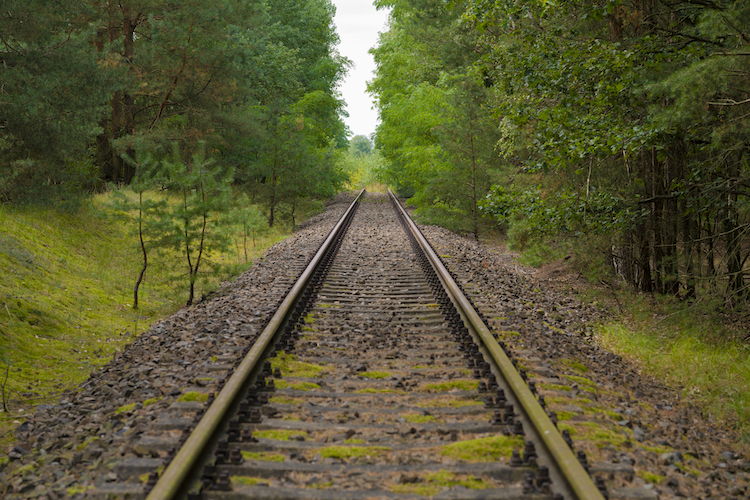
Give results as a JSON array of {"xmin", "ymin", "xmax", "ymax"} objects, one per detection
[{"xmin": 8, "ymin": 189, "xmax": 745, "ymax": 500}]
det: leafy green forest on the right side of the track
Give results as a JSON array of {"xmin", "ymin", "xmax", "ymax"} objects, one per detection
[{"xmin": 370, "ymin": 0, "xmax": 750, "ymax": 309}]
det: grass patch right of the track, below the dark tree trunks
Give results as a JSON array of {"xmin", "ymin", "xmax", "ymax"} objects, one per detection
[{"xmin": 597, "ymin": 296, "xmax": 750, "ymax": 436}]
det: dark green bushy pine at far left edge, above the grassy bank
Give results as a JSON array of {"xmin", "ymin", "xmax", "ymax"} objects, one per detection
[{"xmin": 0, "ymin": 0, "xmax": 115, "ymax": 202}]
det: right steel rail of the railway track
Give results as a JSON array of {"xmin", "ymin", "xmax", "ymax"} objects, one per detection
[{"xmin": 388, "ymin": 189, "xmax": 604, "ymax": 500}]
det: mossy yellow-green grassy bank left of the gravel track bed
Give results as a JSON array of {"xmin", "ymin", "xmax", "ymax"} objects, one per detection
[{"xmin": 0, "ymin": 189, "xmax": 320, "ymax": 448}]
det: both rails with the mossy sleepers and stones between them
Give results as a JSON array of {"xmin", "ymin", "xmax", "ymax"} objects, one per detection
[{"xmin": 137, "ymin": 189, "xmax": 606, "ymax": 500}]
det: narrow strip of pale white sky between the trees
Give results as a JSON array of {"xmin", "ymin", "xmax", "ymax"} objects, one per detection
[{"xmin": 332, "ymin": 0, "xmax": 388, "ymax": 137}]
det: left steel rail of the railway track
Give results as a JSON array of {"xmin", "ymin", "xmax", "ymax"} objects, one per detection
[{"xmin": 146, "ymin": 189, "xmax": 365, "ymax": 500}]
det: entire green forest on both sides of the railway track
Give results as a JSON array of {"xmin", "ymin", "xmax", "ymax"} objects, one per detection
[{"xmin": 0, "ymin": 0, "xmax": 750, "ymax": 309}]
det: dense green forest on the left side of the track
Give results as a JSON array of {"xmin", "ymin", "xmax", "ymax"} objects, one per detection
[{"xmin": 0, "ymin": 0, "xmax": 350, "ymax": 219}]
